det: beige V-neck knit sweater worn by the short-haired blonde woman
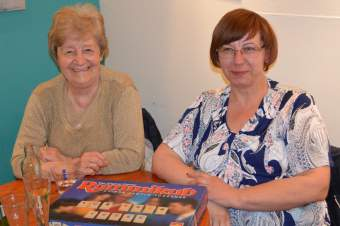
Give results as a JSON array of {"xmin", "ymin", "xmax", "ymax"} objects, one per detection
[{"xmin": 11, "ymin": 67, "xmax": 144, "ymax": 177}]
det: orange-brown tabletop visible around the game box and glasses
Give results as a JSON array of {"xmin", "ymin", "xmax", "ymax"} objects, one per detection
[{"xmin": 0, "ymin": 170, "xmax": 209, "ymax": 226}]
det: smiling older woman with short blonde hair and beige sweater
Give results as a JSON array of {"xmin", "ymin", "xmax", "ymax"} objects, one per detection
[{"xmin": 12, "ymin": 4, "xmax": 144, "ymax": 177}]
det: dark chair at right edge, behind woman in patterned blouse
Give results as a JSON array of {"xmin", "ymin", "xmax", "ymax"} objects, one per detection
[{"xmin": 326, "ymin": 146, "xmax": 340, "ymax": 226}]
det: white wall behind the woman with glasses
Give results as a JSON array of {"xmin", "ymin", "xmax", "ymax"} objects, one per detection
[{"xmin": 100, "ymin": 0, "xmax": 340, "ymax": 146}]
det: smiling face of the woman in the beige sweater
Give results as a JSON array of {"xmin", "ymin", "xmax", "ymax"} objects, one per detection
[{"xmin": 57, "ymin": 35, "xmax": 101, "ymax": 89}]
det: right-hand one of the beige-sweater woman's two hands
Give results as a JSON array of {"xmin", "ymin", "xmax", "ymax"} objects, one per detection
[{"xmin": 73, "ymin": 151, "xmax": 108, "ymax": 175}]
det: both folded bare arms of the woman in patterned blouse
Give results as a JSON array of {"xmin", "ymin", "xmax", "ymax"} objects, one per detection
[{"xmin": 152, "ymin": 144, "xmax": 330, "ymax": 211}]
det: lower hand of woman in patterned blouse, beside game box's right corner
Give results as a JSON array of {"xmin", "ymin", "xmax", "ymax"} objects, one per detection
[{"xmin": 208, "ymin": 201, "xmax": 231, "ymax": 226}]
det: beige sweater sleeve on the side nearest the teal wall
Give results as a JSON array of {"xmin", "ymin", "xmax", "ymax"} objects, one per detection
[{"xmin": 11, "ymin": 93, "xmax": 47, "ymax": 178}]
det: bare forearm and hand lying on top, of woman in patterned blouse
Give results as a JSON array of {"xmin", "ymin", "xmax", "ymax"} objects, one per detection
[{"xmin": 189, "ymin": 166, "xmax": 330, "ymax": 211}]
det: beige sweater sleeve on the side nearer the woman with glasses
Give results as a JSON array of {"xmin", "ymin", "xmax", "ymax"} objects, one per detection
[{"xmin": 100, "ymin": 86, "xmax": 144, "ymax": 174}]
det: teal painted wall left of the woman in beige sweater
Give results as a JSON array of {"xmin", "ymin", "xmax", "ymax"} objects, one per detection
[{"xmin": 0, "ymin": 0, "xmax": 99, "ymax": 184}]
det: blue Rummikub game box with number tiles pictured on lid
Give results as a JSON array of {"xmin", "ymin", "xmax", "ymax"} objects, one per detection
[{"xmin": 49, "ymin": 180, "xmax": 207, "ymax": 226}]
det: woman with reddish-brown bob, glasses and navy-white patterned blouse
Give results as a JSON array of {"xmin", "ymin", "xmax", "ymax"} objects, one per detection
[{"xmin": 153, "ymin": 9, "xmax": 330, "ymax": 226}]
